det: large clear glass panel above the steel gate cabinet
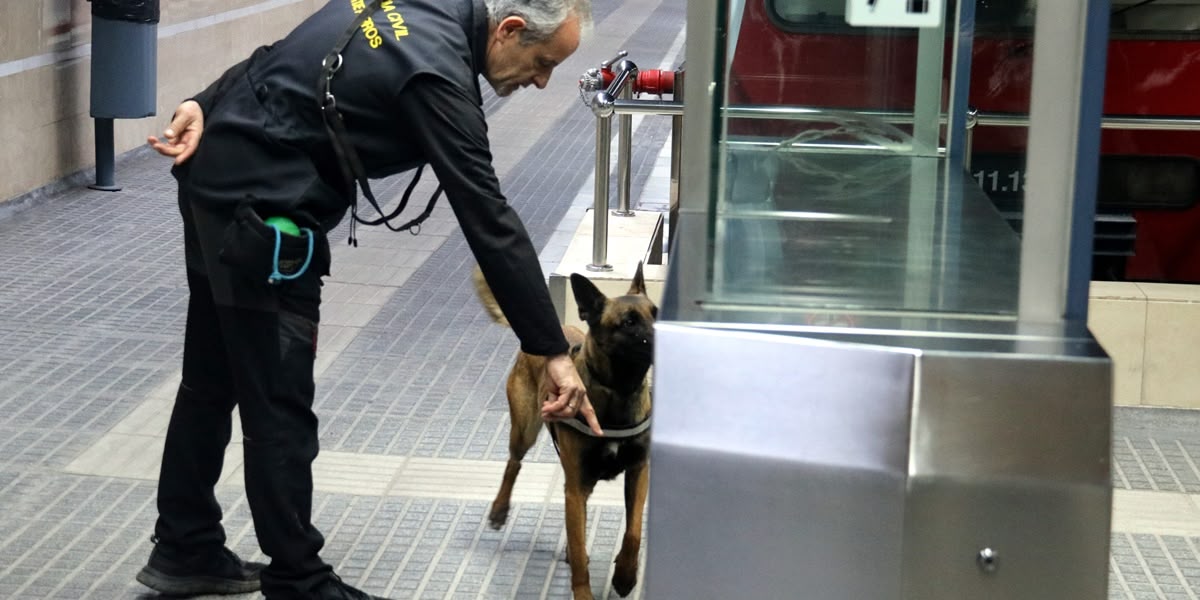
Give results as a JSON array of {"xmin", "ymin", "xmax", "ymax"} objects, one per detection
[{"xmin": 704, "ymin": 0, "xmax": 1028, "ymax": 325}]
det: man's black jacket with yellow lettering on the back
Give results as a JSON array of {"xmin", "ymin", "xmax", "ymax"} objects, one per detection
[{"xmin": 176, "ymin": 0, "xmax": 568, "ymax": 355}]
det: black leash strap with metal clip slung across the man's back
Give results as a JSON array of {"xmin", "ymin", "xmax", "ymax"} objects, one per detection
[{"xmin": 317, "ymin": 0, "xmax": 442, "ymax": 246}]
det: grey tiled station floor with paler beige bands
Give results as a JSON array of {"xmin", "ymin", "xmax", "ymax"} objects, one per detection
[{"xmin": 0, "ymin": 0, "xmax": 1200, "ymax": 600}]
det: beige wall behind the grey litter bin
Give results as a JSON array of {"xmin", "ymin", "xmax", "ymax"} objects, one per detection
[{"xmin": 0, "ymin": 0, "xmax": 324, "ymax": 203}]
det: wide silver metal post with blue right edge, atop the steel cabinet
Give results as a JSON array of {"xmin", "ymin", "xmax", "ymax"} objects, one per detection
[{"xmin": 1018, "ymin": 0, "xmax": 1109, "ymax": 323}]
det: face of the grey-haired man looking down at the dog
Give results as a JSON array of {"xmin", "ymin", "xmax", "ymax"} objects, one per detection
[{"xmin": 484, "ymin": 14, "xmax": 580, "ymax": 96}]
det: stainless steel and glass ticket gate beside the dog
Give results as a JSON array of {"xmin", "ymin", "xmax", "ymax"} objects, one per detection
[{"xmin": 646, "ymin": 0, "xmax": 1111, "ymax": 600}]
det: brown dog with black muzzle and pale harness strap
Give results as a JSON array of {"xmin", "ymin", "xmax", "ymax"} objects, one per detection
[{"xmin": 475, "ymin": 263, "xmax": 658, "ymax": 600}]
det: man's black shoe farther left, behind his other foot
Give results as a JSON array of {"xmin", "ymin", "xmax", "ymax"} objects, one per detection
[{"xmin": 137, "ymin": 538, "xmax": 265, "ymax": 596}]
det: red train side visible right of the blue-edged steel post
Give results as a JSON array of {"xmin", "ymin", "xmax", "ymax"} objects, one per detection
[{"xmin": 1093, "ymin": 0, "xmax": 1200, "ymax": 283}]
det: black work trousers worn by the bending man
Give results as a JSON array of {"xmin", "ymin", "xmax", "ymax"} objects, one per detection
[{"xmin": 155, "ymin": 192, "xmax": 331, "ymax": 600}]
